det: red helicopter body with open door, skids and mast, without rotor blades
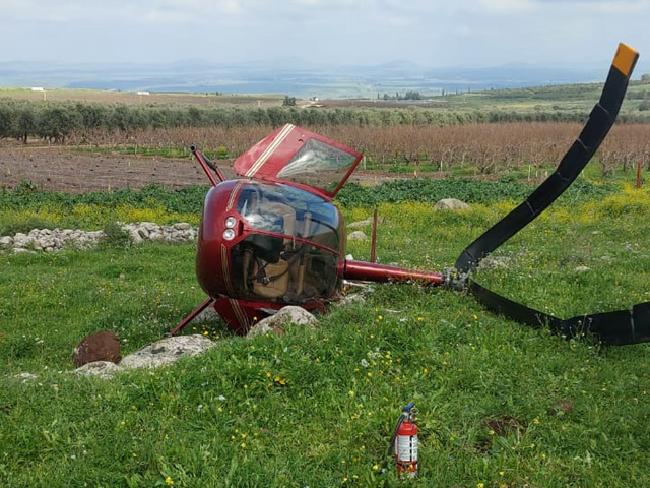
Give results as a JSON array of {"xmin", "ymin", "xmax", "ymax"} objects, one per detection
[{"xmin": 173, "ymin": 124, "xmax": 444, "ymax": 334}]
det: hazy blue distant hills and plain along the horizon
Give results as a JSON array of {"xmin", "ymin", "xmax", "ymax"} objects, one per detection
[{"xmin": 0, "ymin": 60, "xmax": 620, "ymax": 98}]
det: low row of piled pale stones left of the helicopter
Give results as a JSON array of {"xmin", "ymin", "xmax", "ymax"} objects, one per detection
[{"xmin": 0, "ymin": 222, "xmax": 198, "ymax": 252}]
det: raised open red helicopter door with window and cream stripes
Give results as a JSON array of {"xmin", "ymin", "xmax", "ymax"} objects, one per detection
[{"xmin": 235, "ymin": 124, "xmax": 363, "ymax": 199}]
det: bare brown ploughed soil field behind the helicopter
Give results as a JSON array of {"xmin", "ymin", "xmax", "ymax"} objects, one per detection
[{"xmin": 0, "ymin": 146, "xmax": 396, "ymax": 193}]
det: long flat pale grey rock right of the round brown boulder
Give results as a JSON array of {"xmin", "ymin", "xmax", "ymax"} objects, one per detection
[{"xmin": 120, "ymin": 334, "xmax": 215, "ymax": 369}]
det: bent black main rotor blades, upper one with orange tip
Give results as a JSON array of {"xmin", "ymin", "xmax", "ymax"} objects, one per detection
[{"xmin": 456, "ymin": 44, "xmax": 650, "ymax": 345}]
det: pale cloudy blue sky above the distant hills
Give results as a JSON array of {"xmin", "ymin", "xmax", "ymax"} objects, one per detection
[{"xmin": 0, "ymin": 0, "xmax": 650, "ymax": 70}]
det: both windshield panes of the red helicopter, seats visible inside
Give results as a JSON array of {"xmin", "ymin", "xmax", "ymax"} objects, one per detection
[{"xmin": 231, "ymin": 182, "xmax": 342, "ymax": 303}]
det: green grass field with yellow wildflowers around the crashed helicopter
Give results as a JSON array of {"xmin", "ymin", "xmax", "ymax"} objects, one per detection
[{"xmin": 0, "ymin": 176, "xmax": 650, "ymax": 488}]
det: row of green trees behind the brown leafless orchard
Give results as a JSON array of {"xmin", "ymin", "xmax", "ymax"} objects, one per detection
[{"xmin": 0, "ymin": 99, "xmax": 649, "ymax": 143}]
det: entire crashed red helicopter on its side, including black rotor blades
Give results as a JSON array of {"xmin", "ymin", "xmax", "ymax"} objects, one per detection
[{"xmin": 171, "ymin": 44, "xmax": 650, "ymax": 345}]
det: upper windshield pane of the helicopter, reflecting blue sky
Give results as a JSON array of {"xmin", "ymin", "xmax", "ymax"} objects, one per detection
[{"xmin": 237, "ymin": 183, "xmax": 340, "ymax": 250}]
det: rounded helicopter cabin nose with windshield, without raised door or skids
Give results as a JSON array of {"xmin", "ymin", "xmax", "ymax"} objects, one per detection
[{"xmin": 198, "ymin": 180, "xmax": 344, "ymax": 304}]
